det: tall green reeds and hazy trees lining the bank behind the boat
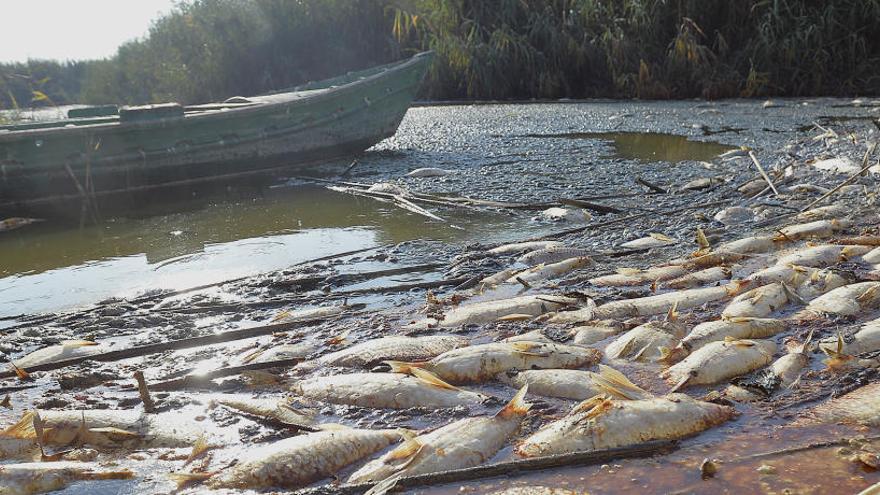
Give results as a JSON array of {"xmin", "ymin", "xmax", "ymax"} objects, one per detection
[{"xmin": 0, "ymin": 0, "xmax": 880, "ymax": 107}]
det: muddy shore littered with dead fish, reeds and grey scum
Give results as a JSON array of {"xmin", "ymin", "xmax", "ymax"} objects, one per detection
[{"xmin": 0, "ymin": 100, "xmax": 880, "ymax": 493}]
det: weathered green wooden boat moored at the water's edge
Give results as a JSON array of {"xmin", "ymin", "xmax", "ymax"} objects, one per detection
[{"xmin": 0, "ymin": 52, "xmax": 432, "ymax": 218}]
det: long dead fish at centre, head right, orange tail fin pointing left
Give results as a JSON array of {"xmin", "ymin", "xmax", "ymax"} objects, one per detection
[{"xmin": 388, "ymin": 342, "xmax": 602, "ymax": 383}]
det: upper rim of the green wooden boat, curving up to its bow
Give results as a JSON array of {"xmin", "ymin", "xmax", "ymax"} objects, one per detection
[{"xmin": 0, "ymin": 51, "xmax": 433, "ymax": 144}]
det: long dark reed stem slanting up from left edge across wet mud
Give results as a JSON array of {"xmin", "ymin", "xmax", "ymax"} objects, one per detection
[{"xmin": 0, "ymin": 318, "xmax": 340, "ymax": 379}]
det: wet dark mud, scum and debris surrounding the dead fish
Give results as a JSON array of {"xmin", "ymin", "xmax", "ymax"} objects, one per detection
[{"xmin": 0, "ymin": 100, "xmax": 880, "ymax": 493}]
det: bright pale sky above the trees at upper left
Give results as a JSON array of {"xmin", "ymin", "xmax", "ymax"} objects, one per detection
[{"xmin": 0, "ymin": 0, "xmax": 176, "ymax": 63}]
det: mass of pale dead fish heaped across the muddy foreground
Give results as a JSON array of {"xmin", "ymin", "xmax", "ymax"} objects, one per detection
[{"xmin": 0, "ymin": 214, "xmax": 880, "ymax": 493}]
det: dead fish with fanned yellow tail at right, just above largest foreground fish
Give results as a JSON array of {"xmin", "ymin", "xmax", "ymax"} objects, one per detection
[{"xmin": 497, "ymin": 364, "xmax": 650, "ymax": 400}]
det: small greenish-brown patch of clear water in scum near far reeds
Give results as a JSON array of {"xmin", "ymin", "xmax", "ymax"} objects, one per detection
[{"xmin": 528, "ymin": 132, "xmax": 731, "ymax": 163}]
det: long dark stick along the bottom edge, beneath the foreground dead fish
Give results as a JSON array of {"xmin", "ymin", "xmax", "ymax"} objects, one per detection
[{"xmin": 297, "ymin": 441, "xmax": 678, "ymax": 495}]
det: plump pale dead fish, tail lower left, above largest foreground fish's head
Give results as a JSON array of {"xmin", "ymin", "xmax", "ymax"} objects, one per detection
[{"xmin": 661, "ymin": 340, "xmax": 776, "ymax": 391}]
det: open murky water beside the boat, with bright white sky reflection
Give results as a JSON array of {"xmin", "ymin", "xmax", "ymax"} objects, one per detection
[{"xmin": 0, "ymin": 186, "xmax": 506, "ymax": 315}]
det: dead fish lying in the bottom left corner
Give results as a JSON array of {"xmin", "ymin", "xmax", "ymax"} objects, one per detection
[{"xmin": 0, "ymin": 461, "xmax": 134, "ymax": 495}]
